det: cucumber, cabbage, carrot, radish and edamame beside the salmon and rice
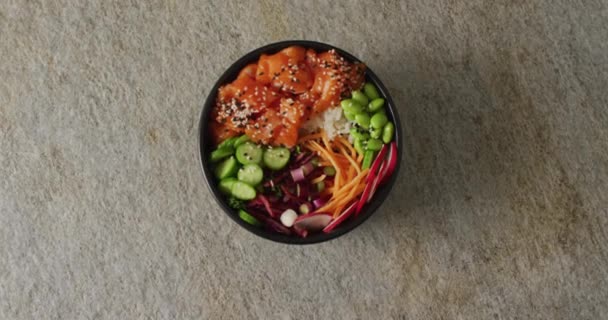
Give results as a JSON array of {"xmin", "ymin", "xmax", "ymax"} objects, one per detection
[{"xmin": 211, "ymin": 83, "xmax": 397, "ymax": 237}]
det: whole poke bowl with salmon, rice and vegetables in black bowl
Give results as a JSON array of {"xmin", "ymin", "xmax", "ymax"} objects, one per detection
[{"xmin": 198, "ymin": 40, "xmax": 403, "ymax": 244}]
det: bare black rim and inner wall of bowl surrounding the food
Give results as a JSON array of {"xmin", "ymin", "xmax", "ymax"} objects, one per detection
[{"xmin": 199, "ymin": 40, "xmax": 403, "ymax": 244}]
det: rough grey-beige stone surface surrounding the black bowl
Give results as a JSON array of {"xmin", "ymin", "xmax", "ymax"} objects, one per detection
[{"xmin": 0, "ymin": 0, "xmax": 608, "ymax": 319}]
